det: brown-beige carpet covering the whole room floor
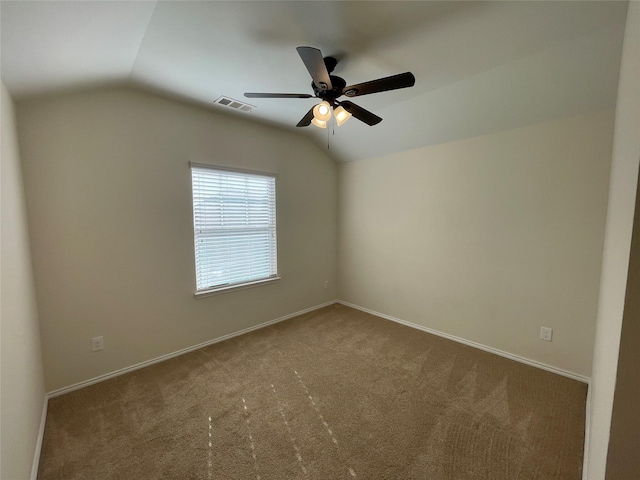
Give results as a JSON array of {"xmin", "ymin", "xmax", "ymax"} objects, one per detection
[{"xmin": 38, "ymin": 305, "xmax": 586, "ymax": 480}]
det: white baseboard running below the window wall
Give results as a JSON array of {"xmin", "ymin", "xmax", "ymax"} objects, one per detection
[{"xmin": 47, "ymin": 300, "xmax": 337, "ymax": 398}]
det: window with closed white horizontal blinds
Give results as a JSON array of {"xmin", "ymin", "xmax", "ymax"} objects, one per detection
[{"xmin": 191, "ymin": 164, "xmax": 278, "ymax": 295}]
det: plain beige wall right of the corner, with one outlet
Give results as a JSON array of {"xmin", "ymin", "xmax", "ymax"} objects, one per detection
[{"xmin": 339, "ymin": 112, "xmax": 613, "ymax": 376}]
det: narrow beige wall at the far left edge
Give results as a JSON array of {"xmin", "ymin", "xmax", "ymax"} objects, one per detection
[{"xmin": 0, "ymin": 84, "xmax": 45, "ymax": 479}]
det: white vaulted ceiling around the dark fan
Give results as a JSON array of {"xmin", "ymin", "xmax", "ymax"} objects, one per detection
[{"xmin": 0, "ymin": 0, "xmax": 627, "ymax": 161}]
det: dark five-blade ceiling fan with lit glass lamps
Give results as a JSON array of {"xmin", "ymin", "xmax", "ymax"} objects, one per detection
[{"xmin": 244, "ymin": 47, "xmax": 416, "ymax": 128}]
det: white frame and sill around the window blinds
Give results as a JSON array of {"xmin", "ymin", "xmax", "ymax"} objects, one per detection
[{"xmin": 189, "ymin": 162, "xmax": 282, "ymax": 298}]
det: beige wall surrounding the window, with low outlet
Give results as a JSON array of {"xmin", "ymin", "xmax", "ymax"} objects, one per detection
[{"xmin": 18, "ymin": 89, "xmax": 337, "ymax": 390}]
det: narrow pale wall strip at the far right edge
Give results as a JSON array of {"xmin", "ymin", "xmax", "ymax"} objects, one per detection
[{"xmin": 584, "ymin": 2, "xmax": 640, "ymax": 480}]
